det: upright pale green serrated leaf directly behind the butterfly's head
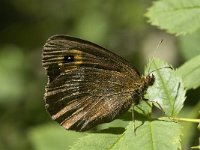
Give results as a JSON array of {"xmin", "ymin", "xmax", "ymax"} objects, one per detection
[{"xmin": 145, "ymin": 59, "xmax": 186, "ymax": 116}]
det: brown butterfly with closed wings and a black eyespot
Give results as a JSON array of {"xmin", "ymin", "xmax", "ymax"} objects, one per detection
[{"xmin": 42, "ymin": 35, "xmax": 154, "ymax": 131}]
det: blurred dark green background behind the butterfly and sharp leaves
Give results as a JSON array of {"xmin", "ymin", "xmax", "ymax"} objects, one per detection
[{"xmin": 0, "ymin": 0, "xmax": 200, "ymax": 150}]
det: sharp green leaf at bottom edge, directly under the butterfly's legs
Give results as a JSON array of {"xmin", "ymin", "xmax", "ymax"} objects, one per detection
[{"xmin": 113, "ymin": 120, "xmax": 181, "ymax": 150}]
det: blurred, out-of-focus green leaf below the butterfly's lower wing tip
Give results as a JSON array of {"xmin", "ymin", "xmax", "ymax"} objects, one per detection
[{"xmin": 28, "ymin": 123, "xmax": 86, "ymax": 150}]
